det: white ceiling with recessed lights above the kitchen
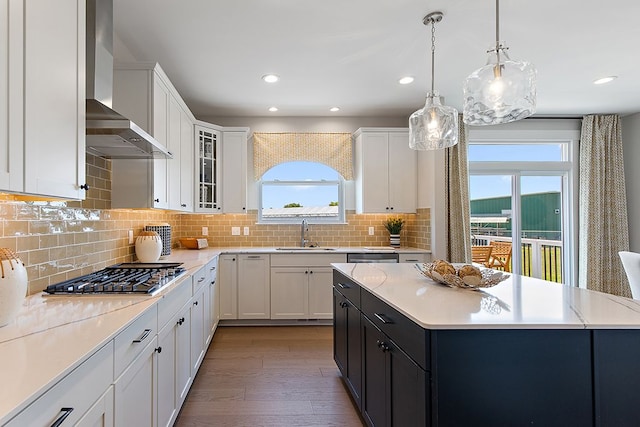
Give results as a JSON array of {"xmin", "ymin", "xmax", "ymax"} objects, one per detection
[{"xmin": 114, "ymin": 0, "xmax": 640, "ymax": 117}]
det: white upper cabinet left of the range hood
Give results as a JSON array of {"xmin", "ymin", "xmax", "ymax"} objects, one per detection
[{"xmin": 0, "ymin": 0, "xmax": 86, "ymax": 199}]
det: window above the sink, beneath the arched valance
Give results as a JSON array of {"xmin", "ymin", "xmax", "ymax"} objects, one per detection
[{"xmin": 258, "ymin": 162, "xmax": 344, "ymax": 223}]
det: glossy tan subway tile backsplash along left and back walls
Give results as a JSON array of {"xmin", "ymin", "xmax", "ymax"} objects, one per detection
[{"xmin": 0, "ymin": 155, "xmax": 431, "ymax": 294}]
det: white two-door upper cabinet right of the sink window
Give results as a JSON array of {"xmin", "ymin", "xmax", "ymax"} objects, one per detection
[{"xmin": 354, "ymin": 128, "xmax": 418, "ymax": 213}]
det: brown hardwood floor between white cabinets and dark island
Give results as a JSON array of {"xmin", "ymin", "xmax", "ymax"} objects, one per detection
[{"xmin": 175, "ymin": 326, "xmax": 363, "ymax": 427}]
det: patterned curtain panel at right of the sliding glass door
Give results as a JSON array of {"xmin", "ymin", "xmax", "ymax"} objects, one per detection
[{"xmin": 579, "ymin": 115, "xmax": 631, "ymax": 298}]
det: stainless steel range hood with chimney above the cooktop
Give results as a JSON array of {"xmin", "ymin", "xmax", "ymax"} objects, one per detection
[{"xmin": 86, "ymin": 0, "xmax": 172, "ymax": 159}]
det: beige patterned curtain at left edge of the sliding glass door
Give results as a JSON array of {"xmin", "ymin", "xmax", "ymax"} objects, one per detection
[{"xmin": 445, "ymin": 117, "xmax": 471, "ymax": 263}]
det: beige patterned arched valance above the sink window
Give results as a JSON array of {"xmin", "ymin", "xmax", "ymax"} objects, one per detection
[{"xmin": 253, "ymin": 132, "xmax": 353, "ymax": 181}]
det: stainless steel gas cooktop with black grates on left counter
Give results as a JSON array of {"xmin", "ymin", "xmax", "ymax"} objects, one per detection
[{"xmin": 44, "ymin": 263, "xmax": 186, "ymax": 295}]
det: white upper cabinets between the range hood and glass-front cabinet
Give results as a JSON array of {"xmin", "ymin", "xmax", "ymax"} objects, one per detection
[{"xmin": 111, "ymin": 63, "xmax": 195, "ymax": 212}]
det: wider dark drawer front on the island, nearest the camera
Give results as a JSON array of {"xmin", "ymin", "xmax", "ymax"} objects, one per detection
[{"xmin": 361, "ymin": 290, "xmax": 430, "ymax": 371}]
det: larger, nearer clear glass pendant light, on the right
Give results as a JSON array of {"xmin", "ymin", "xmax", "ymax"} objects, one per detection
[{"xmin": 463, "ymin": 0, "xmax": 536, "ymax": 125}]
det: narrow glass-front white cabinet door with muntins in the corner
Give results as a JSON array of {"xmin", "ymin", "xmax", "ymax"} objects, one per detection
[{"xmin": 195, "ymin": 125, "xmax": 221, "ymax": 213}]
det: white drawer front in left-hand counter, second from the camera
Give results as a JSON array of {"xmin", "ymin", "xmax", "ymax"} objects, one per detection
[{"xmin": 114, "ymin": 305, "xmax": 158, "ymax": 378}]
